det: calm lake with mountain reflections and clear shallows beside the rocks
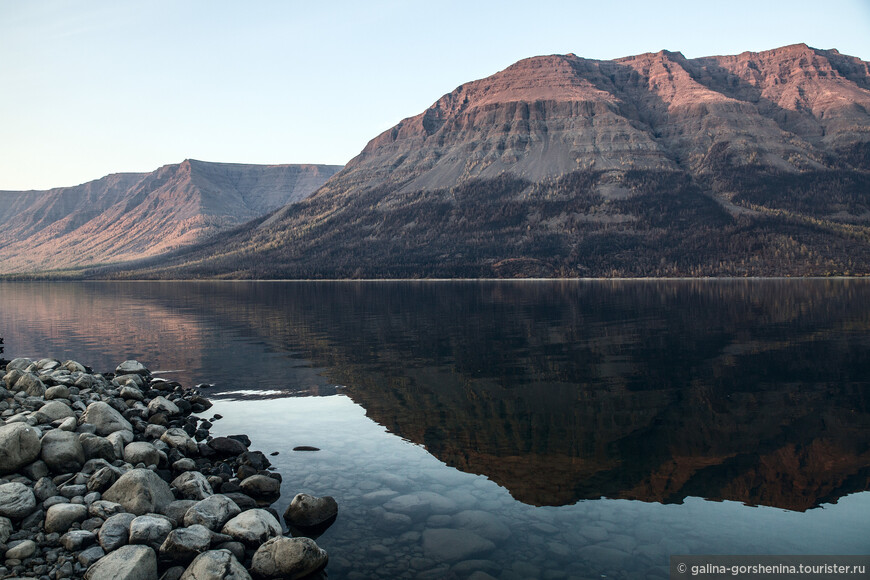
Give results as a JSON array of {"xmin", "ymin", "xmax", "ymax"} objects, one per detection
[{"xmin": 0, "ymin": 280, "xmax": 870, "ymax": 580}]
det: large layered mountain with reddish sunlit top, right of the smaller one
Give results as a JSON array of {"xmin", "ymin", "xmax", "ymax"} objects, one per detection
[{"xmin": 1, "ymin": 45, "xmax": 870, "ymax": 278}]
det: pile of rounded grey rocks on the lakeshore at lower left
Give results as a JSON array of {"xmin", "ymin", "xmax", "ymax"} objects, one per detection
[{"xmin": 0, "ymin": 358, "xmax": 338, "ymax": 580}]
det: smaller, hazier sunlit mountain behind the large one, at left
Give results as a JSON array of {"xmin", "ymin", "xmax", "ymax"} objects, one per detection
[{"xmin": 0, "ymin": 159, "xmax": 340, "ymax": 273}]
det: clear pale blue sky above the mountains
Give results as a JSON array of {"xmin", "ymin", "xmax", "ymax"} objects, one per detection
[{"xmin": 0, "ymin": 0, "xmax": 870, "ymax": 190}]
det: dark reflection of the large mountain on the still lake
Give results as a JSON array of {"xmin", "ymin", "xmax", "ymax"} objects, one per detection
[{"xmin": 2, "ymin": 280, "xmax": 870, "ymax": 511}]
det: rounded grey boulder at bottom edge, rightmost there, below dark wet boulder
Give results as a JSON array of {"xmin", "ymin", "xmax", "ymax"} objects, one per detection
[{"xmin": 251, "ymin": 536, "xmax": 329, "ymax": 580}]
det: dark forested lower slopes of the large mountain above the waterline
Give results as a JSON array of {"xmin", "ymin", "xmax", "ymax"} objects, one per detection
[{"xmin": 92, "ymin": 167, "xmax": 870, "ymax": 279}]
